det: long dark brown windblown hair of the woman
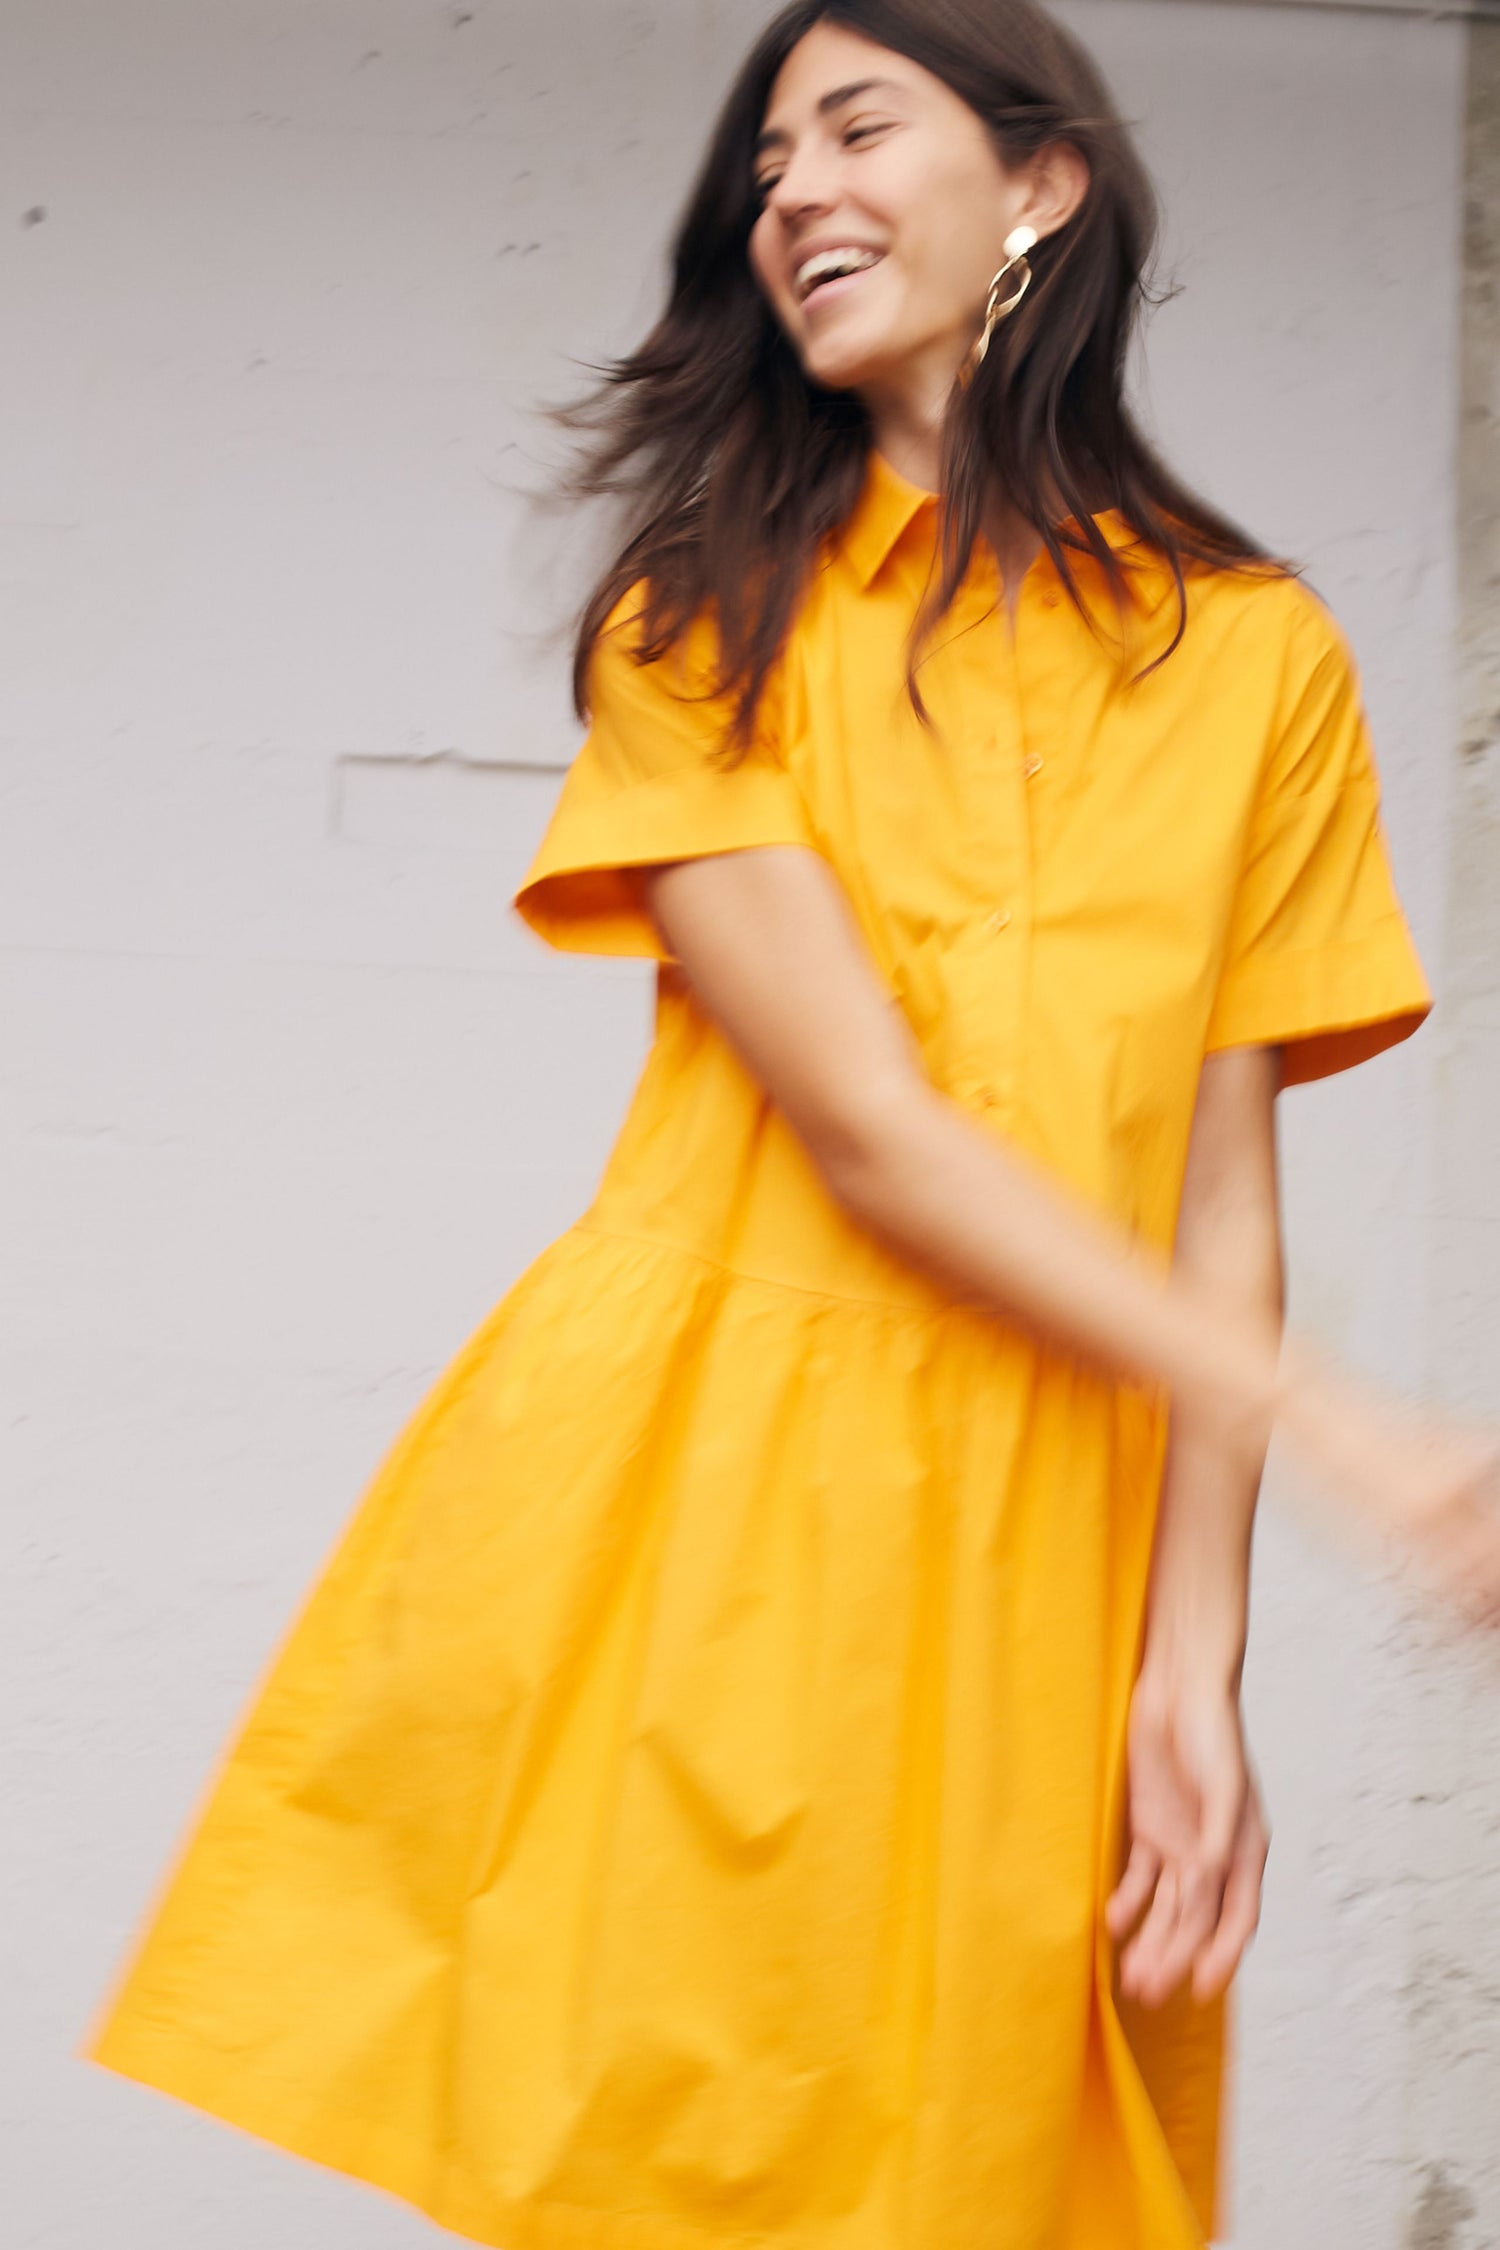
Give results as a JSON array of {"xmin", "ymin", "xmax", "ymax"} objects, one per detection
[{"xmin": 549, "ymin": 0, "xmax": 1277, "ymax": 761}]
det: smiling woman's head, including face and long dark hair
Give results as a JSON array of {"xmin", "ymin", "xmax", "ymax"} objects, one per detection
[{"xmin": 550, "ymin": 0, "xmax": 1295, "ymax": 774}]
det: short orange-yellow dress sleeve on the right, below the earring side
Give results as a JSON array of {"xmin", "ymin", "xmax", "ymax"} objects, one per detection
[{"xmin": 1208, "ymin": 587, "xmax": 1433, "ymax": 1085}]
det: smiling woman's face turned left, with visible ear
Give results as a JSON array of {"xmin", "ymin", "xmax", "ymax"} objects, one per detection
[{"xmin": 749, "ymin": 23, "xmax": 1082, "ymax": 401}]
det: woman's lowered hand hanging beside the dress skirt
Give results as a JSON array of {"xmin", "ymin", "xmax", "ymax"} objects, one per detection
[{"xmin": 1104, "ymin": 1663, "xmax": 1271, "ymax": 2007}]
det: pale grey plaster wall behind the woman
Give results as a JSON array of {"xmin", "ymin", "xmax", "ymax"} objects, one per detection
[{"xmin": 0, "ymin": 0, "xmax": 1500, "ymax": 2250}]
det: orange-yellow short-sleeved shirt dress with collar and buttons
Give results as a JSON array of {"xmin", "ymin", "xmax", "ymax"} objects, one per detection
[{"xmin": 81, "ymin": 455, "xmax": 1428, "ymax": 2250}]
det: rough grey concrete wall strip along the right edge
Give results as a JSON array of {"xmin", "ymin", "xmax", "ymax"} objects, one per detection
[{"xmin": 1408, "ymin": 23, "xmax": 1500, "ymax": 2250}]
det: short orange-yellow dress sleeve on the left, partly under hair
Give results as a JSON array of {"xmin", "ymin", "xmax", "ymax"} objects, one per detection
[{"xmin": 510, "ymin": 583, "xmax": 816, "ymax": 961}]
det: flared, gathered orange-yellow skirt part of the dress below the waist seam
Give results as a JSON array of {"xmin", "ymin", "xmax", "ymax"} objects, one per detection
[{"xmin": 88, "ymin": 1222, "xmax": 1219, "ymax": 2250}]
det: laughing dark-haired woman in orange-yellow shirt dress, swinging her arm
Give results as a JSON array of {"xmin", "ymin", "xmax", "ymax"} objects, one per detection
[{"xmin": 85, "ymin": 0, "xmax": 1500, "ymax": 2250}]
